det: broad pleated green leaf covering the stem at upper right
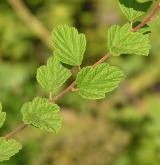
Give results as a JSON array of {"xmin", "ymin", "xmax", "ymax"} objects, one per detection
[{"xmin": 108, "ymin": 24, "xmax": 150, "ymax": 56}]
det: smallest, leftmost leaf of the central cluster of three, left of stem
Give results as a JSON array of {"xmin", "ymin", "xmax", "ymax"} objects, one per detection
[{"xmin": 37, "ymin": 57, "xmax": 71, "ymax": 92}]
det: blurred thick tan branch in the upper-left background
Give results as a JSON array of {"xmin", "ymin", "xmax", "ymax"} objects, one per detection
[{"xmin": 8, "ymin": 0, "xmax": 51, "ymax": 48}]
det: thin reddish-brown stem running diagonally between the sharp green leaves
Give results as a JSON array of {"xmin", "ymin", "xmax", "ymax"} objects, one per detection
[{"xmin": 4, "ymin": 0, "xmax": 160, "ymax": 139}]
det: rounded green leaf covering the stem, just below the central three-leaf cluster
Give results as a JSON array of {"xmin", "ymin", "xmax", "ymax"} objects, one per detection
[{"xmin": 21, "ymin": 97, "xmax": 62, "ymax": 133}]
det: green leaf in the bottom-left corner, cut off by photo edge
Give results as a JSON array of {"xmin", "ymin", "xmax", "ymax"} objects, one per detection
[{"xmin": 0, "ymin": 137, "xmax": 22, "ymax": 162}]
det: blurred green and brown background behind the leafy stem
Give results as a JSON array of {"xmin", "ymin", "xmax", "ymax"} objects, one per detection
[{"xmin": 0, "ymin": 0, "xmax": 160, "ymax": 165}]
